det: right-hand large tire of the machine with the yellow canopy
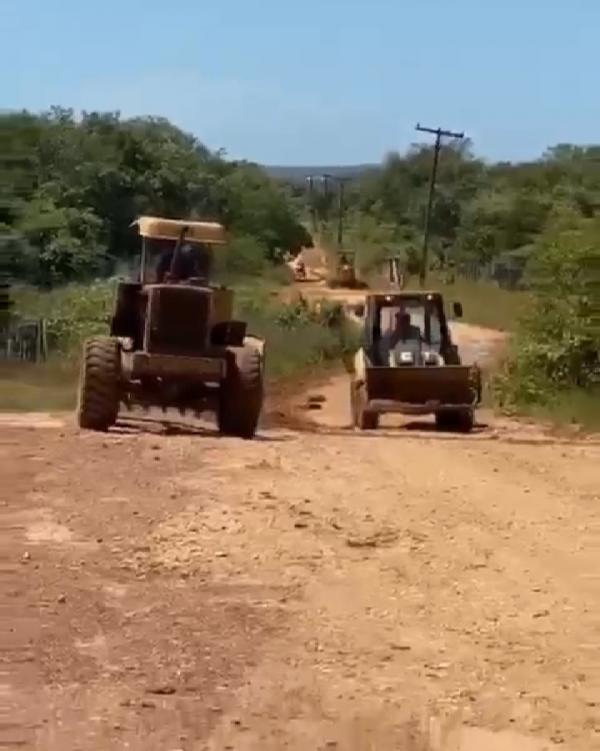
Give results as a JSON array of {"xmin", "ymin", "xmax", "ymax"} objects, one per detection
[{"xmin": 217, "ymin": 347, "xmax": 264, "ymax": 439}]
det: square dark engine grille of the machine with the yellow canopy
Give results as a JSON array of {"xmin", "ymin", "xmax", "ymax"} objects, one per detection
[{"xmin": 144, "ymin": 284, "xmax": 213, "ymax": 356}]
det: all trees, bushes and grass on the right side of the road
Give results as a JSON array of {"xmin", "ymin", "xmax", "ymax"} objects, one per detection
[{"xmin": 300, "ymin": 141, "xmax": 600, "ymax": 428}]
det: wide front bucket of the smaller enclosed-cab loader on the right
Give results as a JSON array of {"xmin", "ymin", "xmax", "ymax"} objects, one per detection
[{"xmin": 366, "ymin": 365, "xmax": 480, "ymax": 415}]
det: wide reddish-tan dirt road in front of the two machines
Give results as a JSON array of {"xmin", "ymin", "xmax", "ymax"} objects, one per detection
[{"xmin": 0, "ymin": 280, "xmax": 600, "ymax": 751}]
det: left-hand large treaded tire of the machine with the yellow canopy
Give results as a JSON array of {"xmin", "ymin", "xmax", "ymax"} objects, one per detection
[{"xmin": 77, "ymin": 336, "xmax": 121, "ymax": 431}]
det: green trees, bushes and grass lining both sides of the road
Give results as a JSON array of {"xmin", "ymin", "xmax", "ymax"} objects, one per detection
[{"xmin": 0, "ymin": 108, "xmax": 600, "ymax": 424}]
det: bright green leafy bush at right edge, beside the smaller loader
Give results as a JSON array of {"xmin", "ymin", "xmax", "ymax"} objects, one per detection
[{"xmin": 495, "ymin": 214, "xmax": 600, "ymax": 428}]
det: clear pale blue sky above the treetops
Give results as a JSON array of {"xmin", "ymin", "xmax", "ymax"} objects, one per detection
[{"xmin": 0, "ymin": 0, "xmax": 600, "ymax": 164}]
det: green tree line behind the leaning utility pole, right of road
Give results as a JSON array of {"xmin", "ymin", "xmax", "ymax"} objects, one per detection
[{"xmin": 302, "ymin": 139, "xmax": 600, "ymax": 288}]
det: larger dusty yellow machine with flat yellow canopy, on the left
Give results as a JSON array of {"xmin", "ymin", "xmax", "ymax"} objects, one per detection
[{"xmin": 77, "ymin": 216, "xmax": 265, "ymax": 438}]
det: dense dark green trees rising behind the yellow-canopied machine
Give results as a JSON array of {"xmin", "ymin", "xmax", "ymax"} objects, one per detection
[{"xmin": 0, "ymin": 107, "xmax": 311, "ymax": 284}]
